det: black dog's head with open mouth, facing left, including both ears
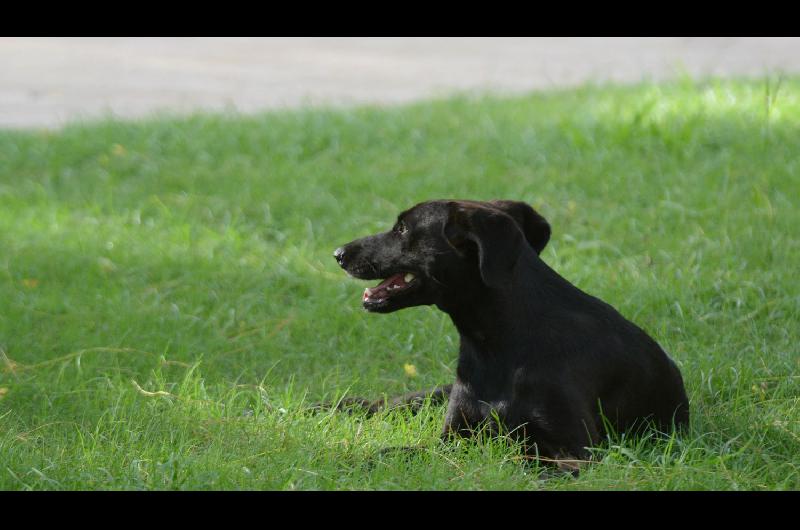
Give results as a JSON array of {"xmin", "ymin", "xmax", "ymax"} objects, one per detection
[{"xmin": 334, "ymin": 200, "xmax": 550, "ymax": 313}]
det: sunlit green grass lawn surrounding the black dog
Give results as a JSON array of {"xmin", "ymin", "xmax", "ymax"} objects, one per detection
[{"xmin": 0, "ymin": 78, "xmax": 800, "ymax": 490}]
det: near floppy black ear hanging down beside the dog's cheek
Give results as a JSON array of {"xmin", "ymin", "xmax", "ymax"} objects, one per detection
[{"xmin": 444, "ymin": 202, "xmax": 525, "ymax": 288}]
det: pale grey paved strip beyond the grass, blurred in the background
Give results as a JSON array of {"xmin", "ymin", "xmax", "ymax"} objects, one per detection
[{"xmin": 0, "ymin": 37, "xmax": 800, "ymax": 127}]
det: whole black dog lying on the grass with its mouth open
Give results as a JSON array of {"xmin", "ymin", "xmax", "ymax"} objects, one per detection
[{"xmin": 334, "ymin": 200, "xmax": 689, "ymax": 459}]
